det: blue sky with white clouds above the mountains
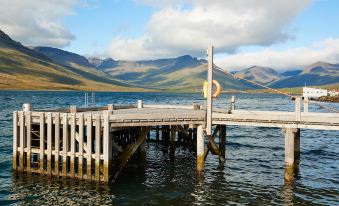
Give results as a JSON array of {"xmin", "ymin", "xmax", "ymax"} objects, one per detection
[{"xmin": 0, "ymin": 0, "xmax": 339, "ymax": 70}]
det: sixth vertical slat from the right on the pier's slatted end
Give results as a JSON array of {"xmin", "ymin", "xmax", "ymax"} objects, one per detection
[{"xmin": 62, "ymin": 113, "xmax": 68, "ymax": 177}]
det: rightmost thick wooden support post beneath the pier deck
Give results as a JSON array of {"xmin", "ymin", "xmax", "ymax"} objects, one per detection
[{"xmin": 285, "ymin": 128, "xmax": 300, "ymax": 182}]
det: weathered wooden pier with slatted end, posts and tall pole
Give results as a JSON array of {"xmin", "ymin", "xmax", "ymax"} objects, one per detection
[{"xmin": 13, "ymin": 47, "xmax": 339, "ymax": 182}]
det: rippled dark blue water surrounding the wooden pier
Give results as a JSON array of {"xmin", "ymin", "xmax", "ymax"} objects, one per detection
[{"xmin": 0, "ymin": 91, "xmax": 339, "ymax": 205}]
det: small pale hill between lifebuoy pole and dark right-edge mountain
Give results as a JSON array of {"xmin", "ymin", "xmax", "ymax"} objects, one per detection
[{"xmin": 235, "ymin": 66, "xmax": 283, "ymax": 84}]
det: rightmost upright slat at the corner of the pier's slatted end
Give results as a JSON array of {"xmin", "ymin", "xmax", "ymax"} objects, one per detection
[{"xmin": 103, "ymin": 113, "xmax": 112, "ymax": 182}]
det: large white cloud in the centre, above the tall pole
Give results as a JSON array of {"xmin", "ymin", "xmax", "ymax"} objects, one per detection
[{"xmin": 108, "ymin": 0, "xmax": 310, "ymax": 60}]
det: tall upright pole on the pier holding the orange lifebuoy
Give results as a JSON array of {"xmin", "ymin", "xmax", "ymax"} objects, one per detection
[{"xmin": 206, "ymin": 45, "xmax": 213, "ymax": 135}]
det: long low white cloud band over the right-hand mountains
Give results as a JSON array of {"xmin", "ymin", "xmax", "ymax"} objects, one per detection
[{"xmin": 215, "ymin": 38, "xmax": 339, "ymax": 71}]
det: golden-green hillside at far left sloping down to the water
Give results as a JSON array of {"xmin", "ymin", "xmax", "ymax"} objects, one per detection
[{"xmin": 0, "ymin": 31, "xmax": 138, "ymax": 91}]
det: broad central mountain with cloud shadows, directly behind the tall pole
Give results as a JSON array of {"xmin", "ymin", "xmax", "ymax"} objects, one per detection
[{"xmin": 93, "ymin": 55, "xmax": 253, "ymax": 91}]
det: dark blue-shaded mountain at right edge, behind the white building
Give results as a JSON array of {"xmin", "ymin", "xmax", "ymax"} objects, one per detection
[{"xmin": 270, "ymin": 62, "xmax": 339, "ymax": 88}]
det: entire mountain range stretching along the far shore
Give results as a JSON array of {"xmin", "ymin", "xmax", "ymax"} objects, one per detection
[{"xmin": 0, "ymin": 30, "xmax": 339, "ymax": 91}]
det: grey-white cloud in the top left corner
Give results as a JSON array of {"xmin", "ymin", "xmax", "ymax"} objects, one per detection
[{"xmin": 0, "ymin": 0, "xmax": 78, "ymax": 47}]
